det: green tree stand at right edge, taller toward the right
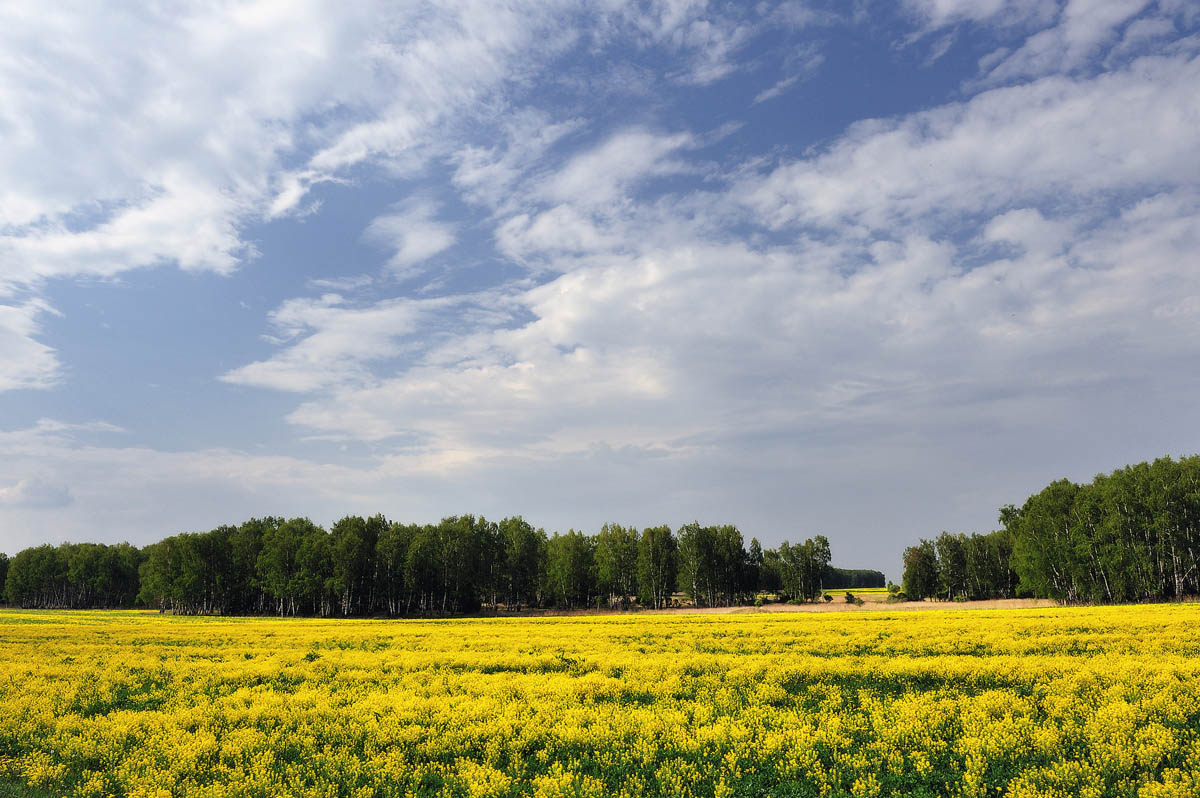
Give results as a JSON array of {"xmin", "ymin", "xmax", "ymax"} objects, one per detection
[{"xmin": 904, "ymin": 456, "xmax": 1200, "ymax": 602}]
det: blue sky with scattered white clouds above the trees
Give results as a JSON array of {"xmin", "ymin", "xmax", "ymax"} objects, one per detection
[{"xmin": 0, "ymin": 0, "xmax": 1200, "ymax": 580}]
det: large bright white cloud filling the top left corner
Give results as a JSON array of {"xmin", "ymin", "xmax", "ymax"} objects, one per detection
[{"xmin": 0, "ymin": 0, "xmax": 585, "ymax": 289}]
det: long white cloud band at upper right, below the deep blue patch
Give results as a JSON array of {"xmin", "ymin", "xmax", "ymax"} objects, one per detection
[{"xmin": 744, "ymin": 52, "xmax": 1200, "ymax": 229}]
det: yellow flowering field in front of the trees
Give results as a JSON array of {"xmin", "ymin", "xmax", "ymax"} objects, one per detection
[{"xmin": 0, "ymin": 605, "xmax": 1200, "ymax": 798}]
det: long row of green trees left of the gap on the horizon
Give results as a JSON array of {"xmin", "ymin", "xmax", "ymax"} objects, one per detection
[{"xmin": 0, "ymin": 515, "xmax": 884, "ymax": 617}]
